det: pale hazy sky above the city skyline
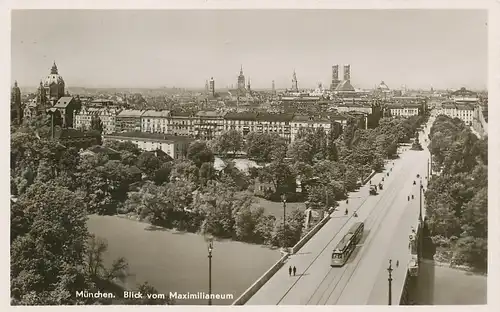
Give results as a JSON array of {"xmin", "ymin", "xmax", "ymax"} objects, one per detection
[{"xmin": 11, "ymin": 9, "xmax": 488, "ymax": 89}]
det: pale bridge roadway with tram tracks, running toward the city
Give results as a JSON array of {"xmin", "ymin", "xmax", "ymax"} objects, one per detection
[{"xmin": 233, "ymin": 121, "xmax": 432, "ymax": 305}]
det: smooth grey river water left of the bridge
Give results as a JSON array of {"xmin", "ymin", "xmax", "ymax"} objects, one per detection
[{"xmin": 88, "ymin": 216, "xmax": 280, "ymax": 305}]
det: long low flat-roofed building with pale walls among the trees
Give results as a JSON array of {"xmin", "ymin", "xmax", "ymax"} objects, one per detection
[{"xmin": 103, "ymin": 132, "xmax": 194, "ymax": 159}]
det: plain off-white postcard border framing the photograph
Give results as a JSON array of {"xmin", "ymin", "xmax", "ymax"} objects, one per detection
[{"xmin": 0, "ymin": 0, "xmax": 500, "ymax": 311}]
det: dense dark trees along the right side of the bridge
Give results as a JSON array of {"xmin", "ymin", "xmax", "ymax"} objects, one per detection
[{"xmin": 425, "ymin": 115, "xmax": 488, "ymax": 271}]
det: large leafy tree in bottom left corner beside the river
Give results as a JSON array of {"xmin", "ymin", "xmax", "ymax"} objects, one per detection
[{"xmin": 11, "ymin": 182, "xmax": 92, "ymax": 304}]
